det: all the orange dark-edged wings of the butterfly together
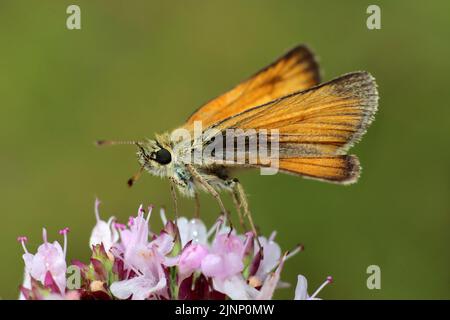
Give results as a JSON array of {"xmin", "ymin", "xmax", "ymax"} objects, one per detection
[{"xmin": 179, "ymin": 46, "xmax": 378, "ymax": 183}]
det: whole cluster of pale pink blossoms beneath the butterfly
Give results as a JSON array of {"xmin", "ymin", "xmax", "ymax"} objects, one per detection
[{"xmin": 18, "ymin": 200, "xmax": 332, "ymax": 300}]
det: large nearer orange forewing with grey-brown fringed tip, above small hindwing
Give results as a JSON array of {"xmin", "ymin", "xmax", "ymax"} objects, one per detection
[{"xmin": 213, "ymin": 72, "xmax": 378, "ymax": 158}]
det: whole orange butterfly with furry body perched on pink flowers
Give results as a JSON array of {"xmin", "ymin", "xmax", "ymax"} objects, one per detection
[{"xmin": 98, "ymin": 45, "xmax": 378, "ymax": 238}]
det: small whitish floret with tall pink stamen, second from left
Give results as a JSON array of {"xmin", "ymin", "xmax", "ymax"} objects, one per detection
[{"xmin": 89, "ymin": 199, "xmax": 119, "ymax": 252}]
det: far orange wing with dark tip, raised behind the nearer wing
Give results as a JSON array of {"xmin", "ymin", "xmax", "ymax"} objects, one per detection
[{"xmin": 184, "ymin": 45, "xmax": 320, "ymax": 129}]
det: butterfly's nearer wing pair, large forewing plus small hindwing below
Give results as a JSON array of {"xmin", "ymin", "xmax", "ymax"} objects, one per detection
[{"xmin": 212, "ymin": 72, "xmax": 378, "ymax": 184}]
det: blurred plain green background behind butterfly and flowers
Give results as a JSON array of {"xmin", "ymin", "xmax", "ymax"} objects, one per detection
[{"xmin": 0, "ymin": 0, "xmax": 450, "ymax": 299}]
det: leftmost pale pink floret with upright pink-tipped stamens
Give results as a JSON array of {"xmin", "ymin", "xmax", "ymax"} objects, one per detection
[{"xmin": 18, "ymin": 228, "xmax": 69, "ymax": 294}]
